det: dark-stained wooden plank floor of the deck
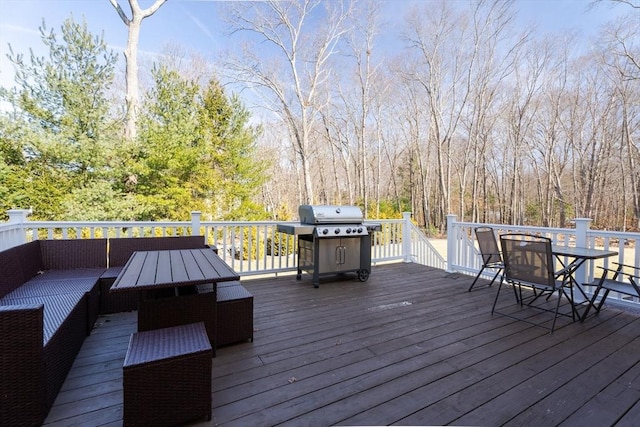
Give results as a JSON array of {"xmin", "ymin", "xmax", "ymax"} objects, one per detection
[{"xmin": 46, "ymin": 263, "xmax": 640, "ymax": 426}]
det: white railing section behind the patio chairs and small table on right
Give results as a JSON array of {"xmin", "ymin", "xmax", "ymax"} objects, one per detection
[{"xmin": 447, "ymin": 215, "xmax": 640, "ymax": 306}]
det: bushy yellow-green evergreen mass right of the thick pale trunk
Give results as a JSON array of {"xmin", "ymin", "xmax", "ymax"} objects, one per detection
[{"xmin": 129, "ymin": 65, "xmax": 264, "ymax": 219}]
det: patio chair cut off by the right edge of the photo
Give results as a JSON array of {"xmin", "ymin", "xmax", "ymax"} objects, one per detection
[{"xmin": 582, "ymin": 262, "xmax": 640, "ymax": 320}]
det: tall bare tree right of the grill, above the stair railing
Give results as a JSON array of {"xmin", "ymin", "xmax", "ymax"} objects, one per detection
[{"xmin": 406, "ymin": 0, "xmax": 512, "ymax": 230}]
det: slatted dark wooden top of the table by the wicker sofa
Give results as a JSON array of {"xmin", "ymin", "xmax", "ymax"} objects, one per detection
[{"xmin": 110, "ymin": 248, "xmax": 240, "ymax": 292}]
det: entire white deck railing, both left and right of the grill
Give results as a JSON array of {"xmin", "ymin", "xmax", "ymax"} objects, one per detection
[{"xmin": 0, "ymin": 210, "xmax": 640, "ymax": 302}]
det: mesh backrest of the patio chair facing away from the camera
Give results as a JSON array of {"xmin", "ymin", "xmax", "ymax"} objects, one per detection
[{"xmin": 500, "ymin": 234, "xmax": 556, "ymax": 288}]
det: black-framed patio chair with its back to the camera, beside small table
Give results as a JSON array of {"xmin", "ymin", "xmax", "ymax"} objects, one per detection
[{"xmin": 491, "ymin": 234, "xmax": 576, "ymax": 333}]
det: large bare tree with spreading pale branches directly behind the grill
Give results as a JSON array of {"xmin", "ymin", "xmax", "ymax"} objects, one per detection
[{"xmin": 228, "ymin": 0, "xmax": 354, "ymax": 203}]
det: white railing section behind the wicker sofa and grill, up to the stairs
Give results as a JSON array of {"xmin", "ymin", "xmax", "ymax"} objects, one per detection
[{"xmin": 0, "ymin": 210, "xmax": 436, "ymax": 276}]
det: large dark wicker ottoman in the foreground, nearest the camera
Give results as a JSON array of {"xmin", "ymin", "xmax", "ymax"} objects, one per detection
[{"xmin": 122, "ymin": 322, "xmax": 212, "ymax": 426}]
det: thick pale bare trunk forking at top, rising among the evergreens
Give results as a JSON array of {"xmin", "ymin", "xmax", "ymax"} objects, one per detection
[{"xmin": 109, "ymin": 0, "xmax": 167, "ymax": 140}]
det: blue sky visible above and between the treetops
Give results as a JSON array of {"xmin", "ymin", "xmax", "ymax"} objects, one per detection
[{"xmin": 0, "ymin": 0, "xmax": 629, "ymax": 92}]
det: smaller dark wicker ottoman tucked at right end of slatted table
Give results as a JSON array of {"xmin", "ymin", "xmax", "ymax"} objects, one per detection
[{"xmin": 216, "ymin": 284, "xmax": 253, "ymax": 346}]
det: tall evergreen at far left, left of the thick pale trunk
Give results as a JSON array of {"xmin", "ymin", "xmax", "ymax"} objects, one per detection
[{"xmin": 0, "ymin": 18, "xmax": 116, "ymax": 219}]
